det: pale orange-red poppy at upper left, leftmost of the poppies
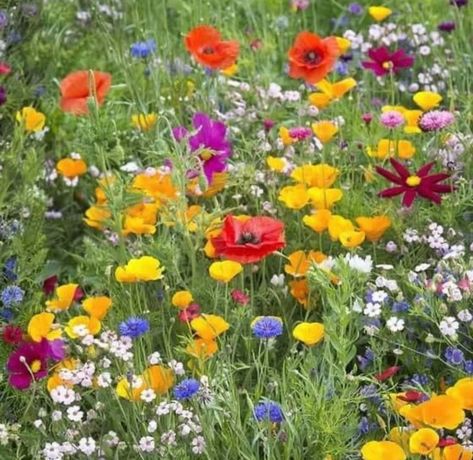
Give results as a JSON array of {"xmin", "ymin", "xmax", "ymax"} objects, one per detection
[{"xmin": 59, "ymin": 70, "xmax": 112, "ymax": 115}]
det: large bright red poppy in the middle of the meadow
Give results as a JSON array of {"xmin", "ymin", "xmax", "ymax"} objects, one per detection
[{"xmin": 212, "ymin": 216, "xmax": 286, "ymax": 264}]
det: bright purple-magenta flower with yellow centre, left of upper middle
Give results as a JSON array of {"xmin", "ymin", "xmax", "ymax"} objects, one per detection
[{"xmin": 173, "ymin": 112, "xmax": 232, "ymax": 184}]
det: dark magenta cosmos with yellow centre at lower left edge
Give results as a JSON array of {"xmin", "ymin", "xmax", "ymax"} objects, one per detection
[{"xmin": 7, "ymin": 340, "xmax": 50, "ymax": 390}]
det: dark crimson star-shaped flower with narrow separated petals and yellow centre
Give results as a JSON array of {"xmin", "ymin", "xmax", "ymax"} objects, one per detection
[{"xmin": 376, "ymin": 158, "xmax": 453, "ymax": 208}]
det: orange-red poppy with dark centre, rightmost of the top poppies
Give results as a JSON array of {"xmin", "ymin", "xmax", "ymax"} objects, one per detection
[{"xmin": 288, "ymin": 32, "xmax": 340, "ymax": 84}]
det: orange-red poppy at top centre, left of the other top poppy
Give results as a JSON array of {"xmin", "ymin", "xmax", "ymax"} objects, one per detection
[{"xmin": 185, "ymin": 25, "xmax": 240, "ymax": 70}]
